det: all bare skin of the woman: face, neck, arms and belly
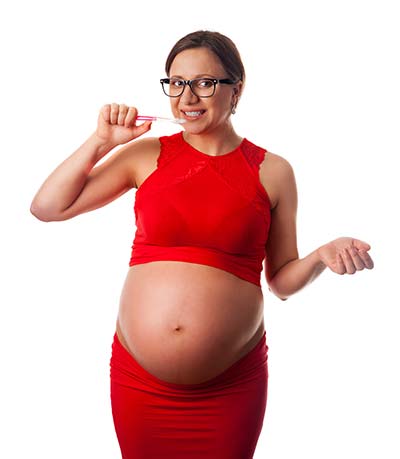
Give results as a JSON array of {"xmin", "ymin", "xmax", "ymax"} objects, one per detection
[{"xmin": 31, "ymin": 48, "xmax": 373, "ymax": 384}]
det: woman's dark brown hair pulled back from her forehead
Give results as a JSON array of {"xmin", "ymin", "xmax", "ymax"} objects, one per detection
[{"xmin": 165, "ymin": 30, "xmax": 246, "ymax": 83}]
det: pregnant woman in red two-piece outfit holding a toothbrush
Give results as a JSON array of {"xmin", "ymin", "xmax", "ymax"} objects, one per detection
[{"xmin": 31, "ymin": 31, "xmax": 373, "ymax": 459}]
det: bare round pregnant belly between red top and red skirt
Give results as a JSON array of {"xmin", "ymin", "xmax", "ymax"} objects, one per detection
[{"xmin": 116, "ymin": 261, "xmax": 264, "ymax": 384}]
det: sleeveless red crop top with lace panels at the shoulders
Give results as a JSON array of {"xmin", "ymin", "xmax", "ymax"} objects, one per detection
[{"xmin": 129, "ymin": 132, "xmax": 271, "ymax": 286}]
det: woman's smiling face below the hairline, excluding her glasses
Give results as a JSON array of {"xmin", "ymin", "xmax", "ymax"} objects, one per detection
[{"xmin": 169, "ymin": 48, "xmax": 241, "ymax": 134}]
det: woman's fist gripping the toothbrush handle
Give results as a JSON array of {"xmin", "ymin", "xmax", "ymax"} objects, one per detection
[{"xmin": 95, "ymin": 103, "xmax": 151, "ymax": 147}]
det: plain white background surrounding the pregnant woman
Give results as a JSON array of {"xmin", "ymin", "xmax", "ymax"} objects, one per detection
[{"xmin": 0, "ymin": 0, "xmax": 400, "ymax": 459}]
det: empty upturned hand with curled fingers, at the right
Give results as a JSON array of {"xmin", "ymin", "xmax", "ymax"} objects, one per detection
[{"xmin": 317, "ymin": 237, "xmax": 374, "ymax": 274}]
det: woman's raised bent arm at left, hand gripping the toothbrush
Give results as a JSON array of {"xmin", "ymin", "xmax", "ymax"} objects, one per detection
[{"xmin": 30, "ymin": 104, "xmax": 151, "ymax": 222}]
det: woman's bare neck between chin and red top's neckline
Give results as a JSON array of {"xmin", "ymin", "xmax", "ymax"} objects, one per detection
[{"xmin": 183, "ymin": 123, "xmax": 242, "ymax": 156}]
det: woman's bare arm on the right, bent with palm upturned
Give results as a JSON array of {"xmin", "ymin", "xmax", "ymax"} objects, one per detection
[{"xmin": 266, "ymin": 155, "xmax": 374, "ymax": 300}]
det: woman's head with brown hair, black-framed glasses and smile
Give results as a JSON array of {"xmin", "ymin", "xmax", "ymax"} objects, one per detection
[{"xmin": 163, "ymin": 31, "xmax": 245, "ymax": 134}]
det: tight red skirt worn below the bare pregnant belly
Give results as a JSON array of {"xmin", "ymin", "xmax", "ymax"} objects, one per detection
[{"xmin": 110, "ymin": 332, "xmax": 268, "ymax": 459}]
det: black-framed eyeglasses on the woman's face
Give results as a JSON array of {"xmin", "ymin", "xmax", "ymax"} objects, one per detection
[{"xmin": 160, "ymin": 78, "xmax": 237, "ymax": 97}]
